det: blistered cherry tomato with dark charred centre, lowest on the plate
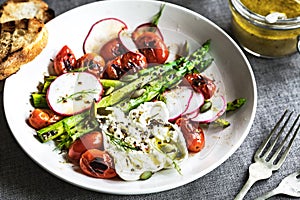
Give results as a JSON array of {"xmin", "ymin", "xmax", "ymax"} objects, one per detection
[{"xmin": 79, "ymin": 149, "xmax": 117, "ymax": 179}]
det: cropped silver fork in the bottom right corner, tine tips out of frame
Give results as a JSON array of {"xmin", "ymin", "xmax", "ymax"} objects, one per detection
[{"xmin": 256, "ymin": 170, "xmax": 300, "ymax": 200}]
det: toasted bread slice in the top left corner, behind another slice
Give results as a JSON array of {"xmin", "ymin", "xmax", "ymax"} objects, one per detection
[{"xmin": 0, "ymin": 0, "xmax": 54, "ymax": 23}]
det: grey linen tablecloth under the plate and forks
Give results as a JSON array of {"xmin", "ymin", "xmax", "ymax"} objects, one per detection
[{"xmin": 0, "ymin": 0, "xmax": 300, "ymax": 200}]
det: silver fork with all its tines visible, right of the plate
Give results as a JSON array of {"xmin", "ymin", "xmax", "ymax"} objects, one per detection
[{"xmin": 235, "ymin": 111, "xmax": 300, "ymax": 200}]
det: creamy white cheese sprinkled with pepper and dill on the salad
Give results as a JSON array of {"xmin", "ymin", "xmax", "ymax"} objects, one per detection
[{"xmin": 98, "ymin": 101, "xmax": 188, "ymax": 180}]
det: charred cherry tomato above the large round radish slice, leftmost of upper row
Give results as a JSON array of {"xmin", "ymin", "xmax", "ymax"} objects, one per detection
[{"xmin": 53, "ymin": 45, "xmax": 76, "ymax": 75}]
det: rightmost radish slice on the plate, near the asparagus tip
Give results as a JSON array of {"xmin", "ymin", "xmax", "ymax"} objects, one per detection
[{"xmin": 192, "ymin": 96, "xmax": 226, "ymax": 123}]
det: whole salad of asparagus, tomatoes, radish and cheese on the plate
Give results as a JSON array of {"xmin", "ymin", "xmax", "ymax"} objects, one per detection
[{"xmin": 28, "ymin": 6, "xmax": 245, "ymax": 180}]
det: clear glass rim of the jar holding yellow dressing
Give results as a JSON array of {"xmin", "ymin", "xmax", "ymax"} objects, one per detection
[{"xmin": 230, "ymin": 0, "xmax": 300, "ymax": 30}]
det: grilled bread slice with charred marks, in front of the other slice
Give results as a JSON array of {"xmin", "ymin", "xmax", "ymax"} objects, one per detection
[{"xmin": 0, "ymin": 18, "xmax": 48, "ymax": 80}]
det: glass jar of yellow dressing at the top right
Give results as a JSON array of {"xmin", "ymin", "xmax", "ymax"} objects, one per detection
[{"xmin": 229, "ymin": 0, "xmax": 300, "ymax": 58}]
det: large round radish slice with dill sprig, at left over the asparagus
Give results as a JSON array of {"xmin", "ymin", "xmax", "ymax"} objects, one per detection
[{"xmin": 47, "ymin": 72, "xmax": 103, "ymax": 116}]
